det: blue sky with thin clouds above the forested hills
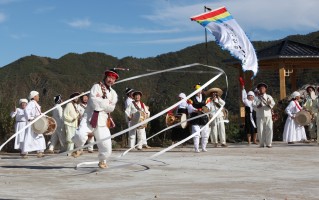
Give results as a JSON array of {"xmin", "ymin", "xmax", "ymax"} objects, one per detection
[{"xmin": 0, "ymin": 0, "xmax": 319, "ymax": 66}]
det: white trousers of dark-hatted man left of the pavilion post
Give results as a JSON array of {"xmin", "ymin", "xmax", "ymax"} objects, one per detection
[{"xmin": 257, "ymin": 117, "xmax": 273, "ymax": 146}]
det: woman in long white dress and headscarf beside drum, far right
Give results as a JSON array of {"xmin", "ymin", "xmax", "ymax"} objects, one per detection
[{"xmin": 282, "ymin": 91, "xmax": 307, "ymax": 144}]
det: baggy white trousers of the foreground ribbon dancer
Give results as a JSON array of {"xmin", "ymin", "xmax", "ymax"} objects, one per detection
[{"xmin": 72, "ymin": 122, "xmax": 112, "ymax": 161}]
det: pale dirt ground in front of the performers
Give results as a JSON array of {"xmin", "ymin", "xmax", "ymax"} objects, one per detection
[{"xmin": 0, "ymin": 142, "xmax": 319, "ymax": 200}]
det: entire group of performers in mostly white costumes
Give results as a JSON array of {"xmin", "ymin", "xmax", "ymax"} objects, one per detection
[{"xmin": 6, "ymin": 69, "xmax": 319, "ymax": 168}]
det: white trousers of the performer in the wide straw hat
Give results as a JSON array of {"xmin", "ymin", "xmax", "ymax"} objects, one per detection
[{"xmin": 210, "ymin": 117, "xmax": 226, "ymax": 144}]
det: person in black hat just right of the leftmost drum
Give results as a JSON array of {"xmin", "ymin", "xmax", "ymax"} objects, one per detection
[{"xmin": 46, "ymin": 95, "xmax": 67, "ymax": 153}]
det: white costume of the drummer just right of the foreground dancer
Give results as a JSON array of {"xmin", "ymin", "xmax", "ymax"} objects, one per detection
[{"xmin": 125, "ymin": 101, "xmax": 150, "ymax": 149}]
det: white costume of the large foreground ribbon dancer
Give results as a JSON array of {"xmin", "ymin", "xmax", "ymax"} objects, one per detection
[{"xmin": 72, "ymin": 84, "xmax": 118, "ymax": 162}]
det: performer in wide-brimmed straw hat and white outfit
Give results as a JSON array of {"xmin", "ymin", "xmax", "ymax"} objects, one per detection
[{"xmin": 206, "ymin": 88, "xmax": 227, "ymax": 147}]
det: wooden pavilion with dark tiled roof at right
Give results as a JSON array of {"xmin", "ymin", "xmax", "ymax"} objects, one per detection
[{"xmin": 233, "ymin": 39, "xmax": 319, "ymax": 117}]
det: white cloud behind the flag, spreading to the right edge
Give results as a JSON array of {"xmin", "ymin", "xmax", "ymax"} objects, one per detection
[{"xmin": 143, "ymin": 0, "xmax": 319, "ymax": 31}]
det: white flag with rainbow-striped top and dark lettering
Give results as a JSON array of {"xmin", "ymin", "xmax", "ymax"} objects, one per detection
[{"xmin": 191, "ymin": 7, "xmax": 258, "ymax": 77}]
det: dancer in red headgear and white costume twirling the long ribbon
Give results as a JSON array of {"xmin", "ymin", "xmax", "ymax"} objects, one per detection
[{"xmin": 72, "ymin": 70, "xmax": 119, "ymax": 168}]
